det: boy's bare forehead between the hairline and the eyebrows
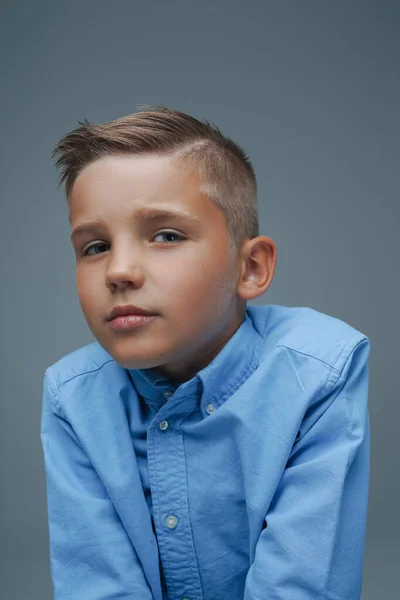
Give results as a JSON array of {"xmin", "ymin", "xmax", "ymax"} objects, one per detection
[{"xmin": 69, "ymin": 155, "xmax": 220, "ymax": 231}]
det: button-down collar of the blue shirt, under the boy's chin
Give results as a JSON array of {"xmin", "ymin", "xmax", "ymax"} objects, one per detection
[{"xmin": 128, "ymin": 307, "xmax": 263, "ymax": 414}]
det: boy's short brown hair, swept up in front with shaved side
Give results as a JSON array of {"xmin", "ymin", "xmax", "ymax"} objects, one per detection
[{"xmin": 52, "ymin": 105, "xmax": 259, "ymax": 253}]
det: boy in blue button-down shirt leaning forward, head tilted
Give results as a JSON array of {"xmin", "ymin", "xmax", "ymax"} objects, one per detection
[{"xmin": 41, "ymin": 107, "xmax": 370, "ymax": 600}]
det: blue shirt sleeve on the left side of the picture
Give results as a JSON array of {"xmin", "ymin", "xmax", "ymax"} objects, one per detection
[{"xmin": 40, "ymin": 368, "xmax": 152, "ymax": 600}]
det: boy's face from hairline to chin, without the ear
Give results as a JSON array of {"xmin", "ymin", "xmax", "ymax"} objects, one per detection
[{"xmin": 70, "ymin": 154, "xmax": 246, "ymax": 382}]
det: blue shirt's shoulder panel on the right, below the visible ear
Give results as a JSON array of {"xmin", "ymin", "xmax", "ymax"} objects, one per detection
[{"xmin": 248, "ymin": 304, "xmax": 369, "ymax": 371}]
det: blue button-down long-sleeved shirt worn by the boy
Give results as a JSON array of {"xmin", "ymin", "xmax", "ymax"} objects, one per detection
[{"xmin": 41, "ymin": 304, "xmax": 370, "ymax": 600}]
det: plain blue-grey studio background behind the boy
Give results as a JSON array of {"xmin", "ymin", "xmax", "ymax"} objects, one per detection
[{"xmin": 0, "ymin": 0, "xmax": 400, "ymax": 600}]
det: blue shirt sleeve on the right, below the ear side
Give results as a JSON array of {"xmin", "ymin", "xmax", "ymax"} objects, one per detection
[{"xmin": 244, "ymin": 337, "xmax": 370, "ymax": 600}]
